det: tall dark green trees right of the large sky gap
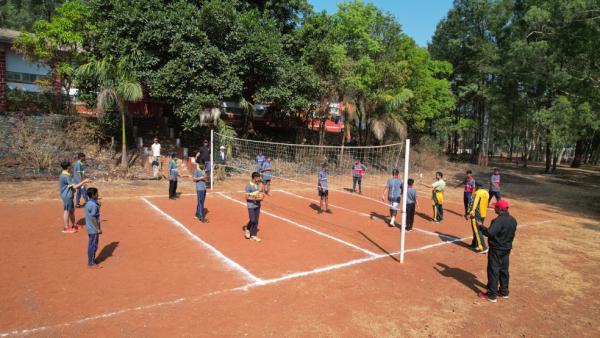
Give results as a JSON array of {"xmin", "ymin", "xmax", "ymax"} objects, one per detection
[{"xmin": 429, "ymin": 0, "xmax": 600, "ymax": 171}]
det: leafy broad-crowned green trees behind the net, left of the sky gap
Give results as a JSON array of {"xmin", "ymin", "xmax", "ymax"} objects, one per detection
[{"xmin": 9, "ymin": 0, "xmax": 454, "ymax": 148}]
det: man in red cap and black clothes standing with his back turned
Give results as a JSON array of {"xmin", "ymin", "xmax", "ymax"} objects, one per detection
[{"xmin": 479, "ymin": 199, "xmax": 517, "ymax": 303}]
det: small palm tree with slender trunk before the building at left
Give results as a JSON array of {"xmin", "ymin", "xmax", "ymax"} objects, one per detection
[{"xmin": 76, "ymin": 57, "xmax": 144, "ymax": 171}]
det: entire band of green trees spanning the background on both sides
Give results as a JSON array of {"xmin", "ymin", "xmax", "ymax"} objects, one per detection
[{"xmin": 6, "ymin": 0, "xmax": 600, "ymax": 170}]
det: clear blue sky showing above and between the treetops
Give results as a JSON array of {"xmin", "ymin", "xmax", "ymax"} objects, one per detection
[{"xmin": 308, "ymin": 0, "xmax": 452, "ymax": 47}]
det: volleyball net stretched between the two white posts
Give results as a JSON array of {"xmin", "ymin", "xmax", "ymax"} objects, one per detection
[{"xmin": 213, "ymin": 132, "xmax": 404, "ymax": 199}]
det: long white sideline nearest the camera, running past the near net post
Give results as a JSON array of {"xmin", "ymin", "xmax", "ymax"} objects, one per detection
[{"xmin": 0, "ymin": 220, "xmax": 553, "ymax": 337}]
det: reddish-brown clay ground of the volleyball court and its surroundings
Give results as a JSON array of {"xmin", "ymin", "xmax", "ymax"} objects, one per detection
[{"xmin": 0, "ymin": 162, "xmax": 600, "ymax": 337}]
